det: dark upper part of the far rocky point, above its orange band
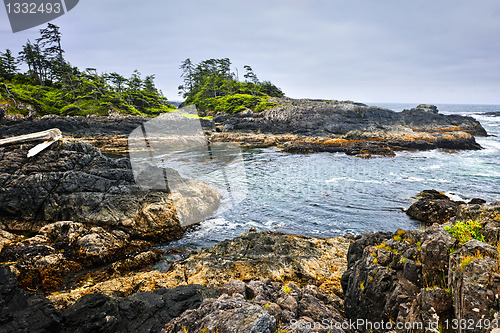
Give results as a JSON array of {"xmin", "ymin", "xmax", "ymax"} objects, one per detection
[{"xmin": 214, "ymin": 98, "xmax": 486, "ymax": 136}]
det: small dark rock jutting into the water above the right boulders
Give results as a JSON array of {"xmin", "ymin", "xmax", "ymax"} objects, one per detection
[{"xmin": 406, "ymin": 190, "xmax": 464, "ymax": 224}]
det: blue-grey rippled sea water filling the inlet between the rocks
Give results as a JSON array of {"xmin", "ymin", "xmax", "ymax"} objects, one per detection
[{"xmin": 158, "ymin": 104, "xmax": 500, "ymax": 249}]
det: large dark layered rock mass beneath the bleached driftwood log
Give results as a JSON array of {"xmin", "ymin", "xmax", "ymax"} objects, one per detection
[{"xmin": 0, "ymin": 141, "xmax": 220, "ymax": 239}]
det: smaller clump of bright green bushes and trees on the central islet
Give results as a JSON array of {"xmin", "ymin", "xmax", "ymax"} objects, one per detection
[{"xmin": 179, "ymin": 58, "xmax": 284, "ymax": 113}]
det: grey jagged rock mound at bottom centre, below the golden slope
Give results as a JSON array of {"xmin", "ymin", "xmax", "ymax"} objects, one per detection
[{"xmin": 162, "ymin": 279, "xmax": 350, "ymax": 333}]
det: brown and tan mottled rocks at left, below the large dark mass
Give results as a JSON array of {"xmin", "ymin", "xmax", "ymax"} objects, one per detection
[{"xmin": 0, "ymin": 221, "xmax": 161, "ymax": 291}]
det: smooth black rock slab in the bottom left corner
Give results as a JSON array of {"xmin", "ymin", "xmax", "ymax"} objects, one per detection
[{"xmin": 0, "ymin": 266, "xmax": 213, "ymax": 333}]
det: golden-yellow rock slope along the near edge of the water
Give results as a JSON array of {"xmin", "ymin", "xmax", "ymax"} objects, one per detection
[{"xmin": 49, "ymin": 230, "xmax": 349, "ymax": 307}]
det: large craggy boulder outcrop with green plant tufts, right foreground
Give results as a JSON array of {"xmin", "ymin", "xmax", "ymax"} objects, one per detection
[{"xmin": 342, "ymin": 198, "xmax": 500, "ymax": 332}]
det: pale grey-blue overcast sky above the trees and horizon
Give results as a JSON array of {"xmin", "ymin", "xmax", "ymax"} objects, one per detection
[{"xmin": 0, "ymin": 0, "xmax": 500, "ymax": 104}]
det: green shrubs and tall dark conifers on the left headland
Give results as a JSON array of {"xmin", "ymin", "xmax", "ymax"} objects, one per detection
[{"xmin": 0, "ymin": 23, "xmax": 175, "ymax": 116}]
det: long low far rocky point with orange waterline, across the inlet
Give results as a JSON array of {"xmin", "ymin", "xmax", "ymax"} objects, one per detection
[{"xmin": 211, "ymin": 99, "xmax": 486, "ymax": 157}]
